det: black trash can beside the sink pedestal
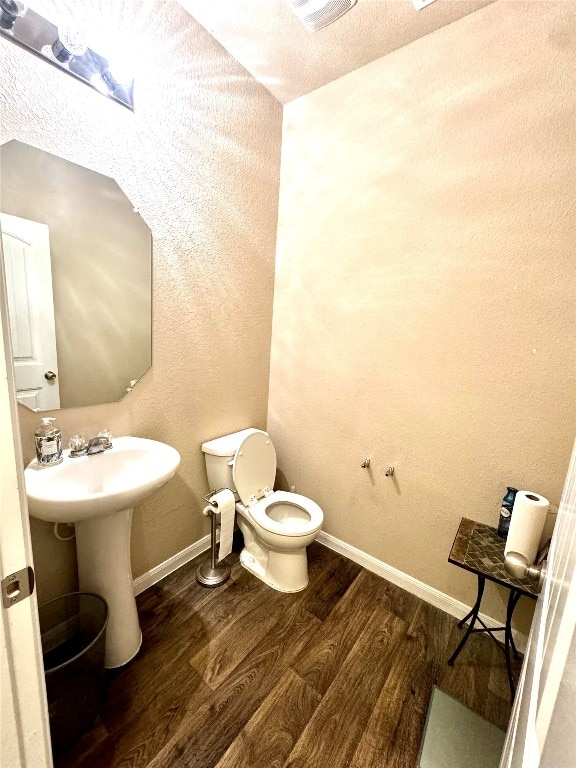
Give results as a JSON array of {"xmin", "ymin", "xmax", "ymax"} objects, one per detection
[{"xmin": 39, "ymin": 592, "xmax": 108, "ymax": 752}]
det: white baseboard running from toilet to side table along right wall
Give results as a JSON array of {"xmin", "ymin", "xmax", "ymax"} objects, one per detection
[{"xmin": 316, "ymin": 531, "xmax": 527, "ymax": 653}]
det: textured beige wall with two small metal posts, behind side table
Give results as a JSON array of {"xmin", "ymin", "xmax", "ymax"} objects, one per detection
[{"xmin": 268, "ymin": 2, "xmax": 576, "ymax": 628}]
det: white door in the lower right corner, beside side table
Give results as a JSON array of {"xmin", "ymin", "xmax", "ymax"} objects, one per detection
[{"xmin": 500, "ymin": 444, "xmax": 576, "ymax": 768}]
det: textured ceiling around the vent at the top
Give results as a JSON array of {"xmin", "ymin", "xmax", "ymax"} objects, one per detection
[{"xmin": 179, "ymin": 0, "xmax": 494, "ymax": 103}]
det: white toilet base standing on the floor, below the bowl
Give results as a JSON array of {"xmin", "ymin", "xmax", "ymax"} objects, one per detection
[{"xmin": 240, "ymin": 544, "xmax": 308, "ymax": 592}]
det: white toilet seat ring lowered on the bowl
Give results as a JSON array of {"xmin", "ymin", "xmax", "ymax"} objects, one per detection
[{"xmin": 246, "ymin": 491, "xmax": 324, "ymax": 537}]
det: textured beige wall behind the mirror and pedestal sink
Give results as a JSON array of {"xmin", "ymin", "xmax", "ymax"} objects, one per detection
[{"xmin": 0, "ymin": 0, "xmax": 282, "ymax": 600}]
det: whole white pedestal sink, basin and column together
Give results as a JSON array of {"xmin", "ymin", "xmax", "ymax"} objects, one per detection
[{"xmin": 24, "ymin": 437, "xmax": 180, "ymax": 668}]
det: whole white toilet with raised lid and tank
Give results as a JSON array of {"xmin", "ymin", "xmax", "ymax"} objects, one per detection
[{"xmin": 202, "ymin": 429, "xmax": 324, "ymax": 592}]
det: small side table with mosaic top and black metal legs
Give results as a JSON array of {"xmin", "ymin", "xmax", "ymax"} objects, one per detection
[{"xmin": 448, "ymin": 517, "xmax": 538, "ymax": 699}]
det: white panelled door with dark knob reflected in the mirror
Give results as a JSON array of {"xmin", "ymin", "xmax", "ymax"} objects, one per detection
[{"xmin": 0, "ymin": 213, "xmax": 60, "ymax": 411}]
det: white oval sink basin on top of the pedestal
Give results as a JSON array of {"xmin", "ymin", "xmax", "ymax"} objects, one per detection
[{"xmin": 24, "ymin": 437, "xmax": 180, "ymax": 523}]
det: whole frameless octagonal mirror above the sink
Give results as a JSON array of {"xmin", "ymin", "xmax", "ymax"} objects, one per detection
[{"xmin": 0, "ymin": 141, "xmax": 152, "ymax": 411}]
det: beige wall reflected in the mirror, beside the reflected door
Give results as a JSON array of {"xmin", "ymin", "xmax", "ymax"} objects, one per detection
[{"xmin": 0, "ymin": 141, "xmax": 152, "ymax": 408}]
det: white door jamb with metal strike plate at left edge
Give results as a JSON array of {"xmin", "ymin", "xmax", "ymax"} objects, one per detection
[{"xmin": 0, "ymin": 249, "xmax": 52, "ymax": 768}]
